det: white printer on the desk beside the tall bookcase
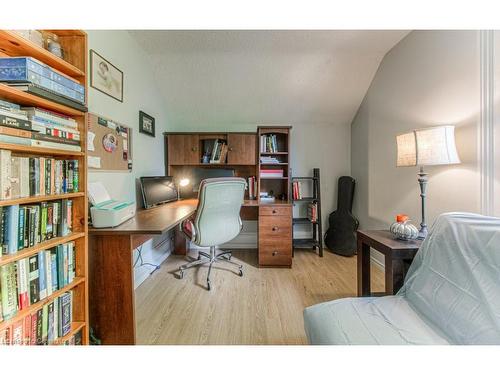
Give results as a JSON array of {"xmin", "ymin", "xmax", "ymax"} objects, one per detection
[{"xmin": 89, "ymin": 182, "xmax": 135, "ymax": 228}]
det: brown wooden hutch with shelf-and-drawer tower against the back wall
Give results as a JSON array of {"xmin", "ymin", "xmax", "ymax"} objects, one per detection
[{"xmin": 164, "ymin": 126, "xmax": 292, "ymax": 267}]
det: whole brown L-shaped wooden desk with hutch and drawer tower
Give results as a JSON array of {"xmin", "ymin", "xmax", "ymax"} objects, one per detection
[{"xmin": 89, "ymin": 127, "xmax": 292, "ymax": 345}]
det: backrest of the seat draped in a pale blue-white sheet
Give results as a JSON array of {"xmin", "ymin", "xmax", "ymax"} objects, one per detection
[{"xmin": 398, "ymin": 213, "xmax": 500, "ymax": 344}]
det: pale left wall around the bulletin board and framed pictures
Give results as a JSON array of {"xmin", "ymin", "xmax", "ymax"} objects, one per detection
[{"xmin": 87, "ymin": 30, "xmax": 170, "ymax": 285}]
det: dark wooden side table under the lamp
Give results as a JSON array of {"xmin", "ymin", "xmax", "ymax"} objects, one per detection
[{"xmin": 357, "ymin": 230, "xmax": 422, "ymax": 297}]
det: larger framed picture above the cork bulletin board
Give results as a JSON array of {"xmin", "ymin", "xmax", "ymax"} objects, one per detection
[{"xmin": 90, "ymin": 49, "xmax": 123, "ymax": 103}]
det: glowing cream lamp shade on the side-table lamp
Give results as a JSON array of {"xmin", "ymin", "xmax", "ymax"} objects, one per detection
[{"xmin": 396, "ymin": 125, "xmax": 460, "ymax": 167}]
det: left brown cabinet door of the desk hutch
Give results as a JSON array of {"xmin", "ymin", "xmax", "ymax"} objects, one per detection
[{"xmin": 168, "ymin": 134, "xmax": 200, "ymax": 165}]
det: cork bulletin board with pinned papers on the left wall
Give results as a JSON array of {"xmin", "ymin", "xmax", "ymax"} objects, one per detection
[{"xmin": 87, "ymin": 113, "xmax": 132, "ymax": 172}]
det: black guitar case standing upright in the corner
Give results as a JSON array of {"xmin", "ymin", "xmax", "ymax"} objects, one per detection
[{"xmin": 325, "ymin": 176, "xmax": 359, "ymax": 256}]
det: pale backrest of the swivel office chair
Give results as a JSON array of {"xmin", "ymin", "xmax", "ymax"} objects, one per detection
[{"xmin": 193, "ymin": 177, "xmax": 246, "ymax": 247}]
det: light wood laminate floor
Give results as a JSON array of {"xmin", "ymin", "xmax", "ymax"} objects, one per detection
[{"xmin": 136, "ymin": 250, "xmax": 384, "ymax": 345}]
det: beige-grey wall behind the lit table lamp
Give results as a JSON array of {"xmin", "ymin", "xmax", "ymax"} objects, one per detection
[{"xmin": 351, "ymin": 31, "xmax": 480, "ymax": 260}]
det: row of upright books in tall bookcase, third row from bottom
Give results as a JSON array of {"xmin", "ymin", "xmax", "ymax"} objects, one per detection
[{"xmin": 0, "ymin": 199, "xmax": 73, "ymax": 257}]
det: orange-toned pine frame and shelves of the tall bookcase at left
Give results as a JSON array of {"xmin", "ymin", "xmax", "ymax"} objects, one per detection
[{"xmin": 0, "ymin": 30, "xmax": 89, "ymax": 345}]
